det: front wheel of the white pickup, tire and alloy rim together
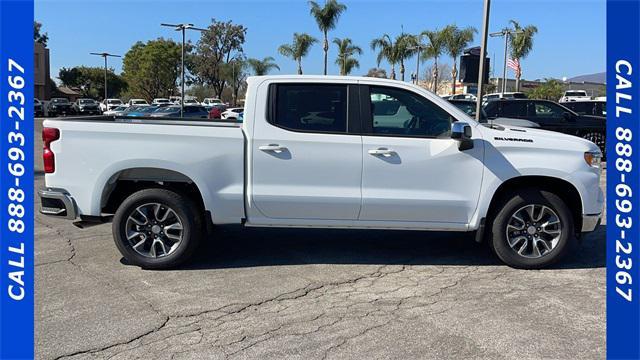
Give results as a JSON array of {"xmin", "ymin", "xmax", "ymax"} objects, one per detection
[{"xmin": 490, "ymin": 189, "xmax": 576, "ymax": 269}]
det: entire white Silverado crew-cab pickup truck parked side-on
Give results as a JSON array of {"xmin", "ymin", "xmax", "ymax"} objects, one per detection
[{"xmin": 39, "ymin": 76, "xmax": 604, "ymax": 268}]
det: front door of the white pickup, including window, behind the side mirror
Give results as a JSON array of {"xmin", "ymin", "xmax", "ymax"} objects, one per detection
[{"xmin": 359, "ymin": 86, "xmax": 484, "ymax": 227}]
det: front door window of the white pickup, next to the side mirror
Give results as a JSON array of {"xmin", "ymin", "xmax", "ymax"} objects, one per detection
[{"xmin": 369, "ymin": 86, "xmax": 453, "ymax": 137}]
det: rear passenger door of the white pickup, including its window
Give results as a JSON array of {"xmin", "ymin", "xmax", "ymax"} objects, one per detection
[{"xmin": 250, "ymin": 82, "xmax": 362, "ymax": 220}]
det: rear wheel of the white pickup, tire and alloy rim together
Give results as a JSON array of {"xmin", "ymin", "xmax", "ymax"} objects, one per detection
[{"xmin": 112, "ymin": 189, "xmax": 203, "ymax": 269}]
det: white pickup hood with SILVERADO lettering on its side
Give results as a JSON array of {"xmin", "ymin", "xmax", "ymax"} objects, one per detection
[{"xmin": 477, "ymin": 124, "xmax": 600, "ymax": 153}]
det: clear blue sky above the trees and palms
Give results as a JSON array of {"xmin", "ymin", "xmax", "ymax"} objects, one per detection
[{"xmin": 35, "ymin": 0, "xmax": 606, "ymax": 80}]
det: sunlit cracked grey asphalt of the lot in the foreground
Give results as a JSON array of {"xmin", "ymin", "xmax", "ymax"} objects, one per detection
[{"xmin": 35, "ymin": 119, "xmax": 605, "ymax": 359}]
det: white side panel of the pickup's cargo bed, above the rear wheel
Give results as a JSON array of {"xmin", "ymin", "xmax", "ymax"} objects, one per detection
[{"xmin": 43, "ymin": 116, "xmax": 245, "ymax": 223}]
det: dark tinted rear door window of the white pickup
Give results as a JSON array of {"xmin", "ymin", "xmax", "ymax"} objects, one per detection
[{"xmin": 270, "ymin": 84, "xmax": 347, "ymax": 133}]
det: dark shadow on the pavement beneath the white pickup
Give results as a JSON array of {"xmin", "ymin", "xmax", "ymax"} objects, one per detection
[{"xmin": 159, "ymin": 226, "xmax": 606, "ymax": 270}]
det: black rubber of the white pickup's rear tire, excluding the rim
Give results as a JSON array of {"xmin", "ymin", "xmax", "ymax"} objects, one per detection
[{"xmin": 112, "ymin": 189, "xmax": 202, "ymax": 269}]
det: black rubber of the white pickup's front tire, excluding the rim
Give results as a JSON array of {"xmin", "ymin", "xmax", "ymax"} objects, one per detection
[{"xmin": 490, "ymin": 189, "xmax": 575, "ymax": 269}]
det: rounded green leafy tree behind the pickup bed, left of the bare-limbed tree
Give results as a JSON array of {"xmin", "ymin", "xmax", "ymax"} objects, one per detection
[{"xmin": 122, "ymin": 38, "xmax": 182, "ymax": 101}]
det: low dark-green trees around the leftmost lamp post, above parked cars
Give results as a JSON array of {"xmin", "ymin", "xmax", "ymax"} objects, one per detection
[{"xmin": 58, "ymin": 66, "xmax": 127, "ymax": 99}]
